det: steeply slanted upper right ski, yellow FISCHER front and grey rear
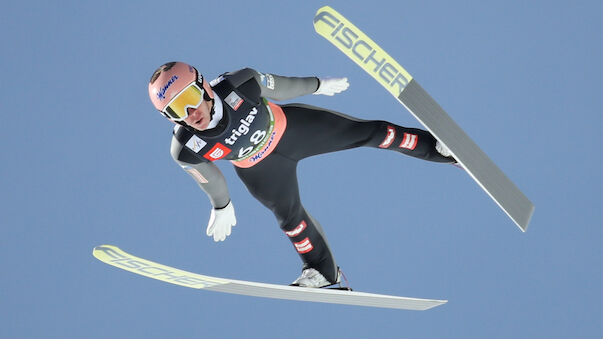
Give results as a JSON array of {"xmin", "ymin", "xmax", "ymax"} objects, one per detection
[{"xmin": 314, "ymin": 6, "xmax": 534, "ymax": 232}]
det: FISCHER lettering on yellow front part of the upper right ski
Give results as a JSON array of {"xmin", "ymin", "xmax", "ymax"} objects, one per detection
[{"xmin": 314, "ymin": 11, "xmax": 411, "ymax": 94}]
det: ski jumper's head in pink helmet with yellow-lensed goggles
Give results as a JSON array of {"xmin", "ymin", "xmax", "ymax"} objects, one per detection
[{"xmin": 149, "ymin": 62, "xmax": 214, "ymax": 130}]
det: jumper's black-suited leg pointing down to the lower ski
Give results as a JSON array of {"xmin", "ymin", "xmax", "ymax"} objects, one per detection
[{"xmin": 236, "ymin": 152, "xmax": 338, "ymax": 283}]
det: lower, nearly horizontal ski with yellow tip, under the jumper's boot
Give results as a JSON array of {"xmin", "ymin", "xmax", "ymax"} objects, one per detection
[{"xmin": 92, "ymin": 245, "xmax": 447, "ymax": 311}]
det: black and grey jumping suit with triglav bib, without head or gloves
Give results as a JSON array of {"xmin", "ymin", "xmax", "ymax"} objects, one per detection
[{"xmin": 171, "ymin": 68, "xmax": 454, "ymax": 282}]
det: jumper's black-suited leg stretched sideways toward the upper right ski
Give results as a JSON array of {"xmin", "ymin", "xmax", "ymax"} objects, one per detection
[{"xmin": 277, "ymin": 104, "xmax": 454, "ymax": 162}]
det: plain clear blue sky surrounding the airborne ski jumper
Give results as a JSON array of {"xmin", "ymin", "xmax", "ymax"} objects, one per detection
[{"xmin": 0, "ymin": 0, "xmax": 603, "ymax": 338}]
